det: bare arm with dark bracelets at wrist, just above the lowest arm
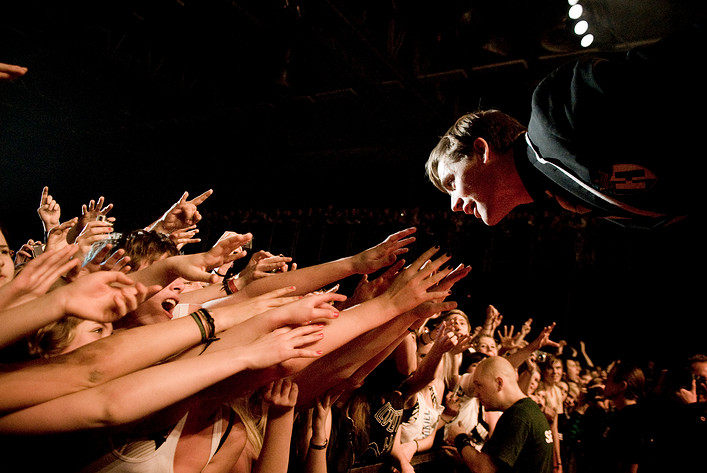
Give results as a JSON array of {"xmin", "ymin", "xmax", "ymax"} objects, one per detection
[{"xmin": 0, "ymin": 282, "xmax": 307, "ymax": 412}]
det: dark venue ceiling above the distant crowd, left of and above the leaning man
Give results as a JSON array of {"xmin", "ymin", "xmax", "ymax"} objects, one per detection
[{"xmin": 0, "ymin": 0, "xmax": 699, "ymax": 234}]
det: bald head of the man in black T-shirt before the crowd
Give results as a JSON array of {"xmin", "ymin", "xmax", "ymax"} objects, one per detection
[{"xmin": 474, "ymin": 356, "xmax": 526, "ymax": 411}]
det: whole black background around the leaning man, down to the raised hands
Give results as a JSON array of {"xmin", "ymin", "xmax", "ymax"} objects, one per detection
[{"xmin": 0, "ymin": 0, "xmax": 706, "ymax": 361}]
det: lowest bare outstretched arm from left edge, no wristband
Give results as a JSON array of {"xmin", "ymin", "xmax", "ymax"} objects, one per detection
[{"xmin": 0, "ymin": 326, "xmax": 320, "ymax": 434}]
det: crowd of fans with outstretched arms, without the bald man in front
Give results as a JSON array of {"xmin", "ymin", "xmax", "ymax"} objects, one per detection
[{"xmin": 0, "ymin": 183, "xmax": 707, "ymax": 473}]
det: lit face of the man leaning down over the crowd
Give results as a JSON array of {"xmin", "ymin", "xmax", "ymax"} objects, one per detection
[{"xmin": 438, "ymin": 154, "xmax": 507, "ymax": 225}]
